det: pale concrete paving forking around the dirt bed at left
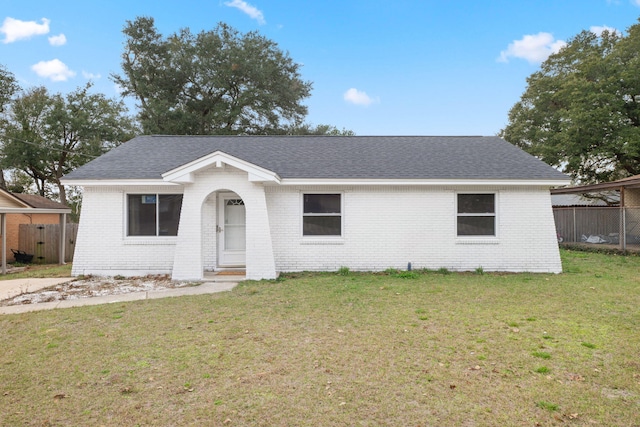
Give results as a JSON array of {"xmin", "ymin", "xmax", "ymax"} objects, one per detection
[{"xmin": 0, "ymin": 277, "xmax": 238, "ymax": 314}]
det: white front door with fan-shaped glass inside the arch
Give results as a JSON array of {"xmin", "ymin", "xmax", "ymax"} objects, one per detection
[{"xmin": 217, "ymin": 193, "xmax": 247, "ymax": 267}]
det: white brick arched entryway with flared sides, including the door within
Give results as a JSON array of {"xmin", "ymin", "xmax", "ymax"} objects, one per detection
[{"xmin": 172, "ymin": 166, "xmax": 277, "ymax": 280}]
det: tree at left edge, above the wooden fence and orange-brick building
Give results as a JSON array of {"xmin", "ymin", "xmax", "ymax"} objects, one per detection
[{"xmin": 0, "ymin": 84, "xmax": 136, "ymax": 203}]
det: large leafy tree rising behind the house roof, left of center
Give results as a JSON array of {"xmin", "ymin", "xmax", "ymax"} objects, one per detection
[{"xmin": 111, "ymin": 17, "xmax": 311, "ymax": 135}]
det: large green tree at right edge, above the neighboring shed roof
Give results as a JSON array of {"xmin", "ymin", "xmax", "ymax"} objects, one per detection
[{"xmin": 500, "ymin": 24, "xmax": 640, "ymax": 183}]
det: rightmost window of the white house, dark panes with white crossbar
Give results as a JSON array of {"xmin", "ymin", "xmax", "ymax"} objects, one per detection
[{"xmin": 457, "ymin": 193, "xmax": 496, "ymax": 236}]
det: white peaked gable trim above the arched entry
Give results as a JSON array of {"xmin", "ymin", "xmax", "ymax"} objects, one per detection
[{"xmin": 162, "ymin": 151, "xmax": 280, "ymax": 184}]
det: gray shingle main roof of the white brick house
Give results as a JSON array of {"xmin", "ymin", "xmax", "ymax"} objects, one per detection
[{"xmin": 65, "ymin": 136, "xmax": 568, "ymax": 180}]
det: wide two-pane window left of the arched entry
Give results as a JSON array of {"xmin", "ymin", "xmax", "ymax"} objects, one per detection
[{"xmin": 127, "ymin": 194, "xmax": 182, "ymax": 236}]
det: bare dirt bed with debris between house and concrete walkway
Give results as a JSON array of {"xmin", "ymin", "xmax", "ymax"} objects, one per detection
[{"xmin": 0, "ymin": 276, "xmax": 199, "ymax": 306}]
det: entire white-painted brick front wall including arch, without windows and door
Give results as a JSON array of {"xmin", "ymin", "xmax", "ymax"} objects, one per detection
[{"xmin": 73, "ymin": 176, "xmax": 561, "ymax": 279}]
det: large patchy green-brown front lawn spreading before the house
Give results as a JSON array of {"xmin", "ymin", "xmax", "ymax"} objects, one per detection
[{"xmin": 0, "ymin": 251, "xmax": 640, "ymax": 426}]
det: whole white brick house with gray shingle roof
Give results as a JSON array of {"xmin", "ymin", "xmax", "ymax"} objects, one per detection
[{"xmin": 64, "ymin": 136, "xmax": 568, "ymax": 280}]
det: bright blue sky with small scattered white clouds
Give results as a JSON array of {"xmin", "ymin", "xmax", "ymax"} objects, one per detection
[{"xmin": 0, "ymin": 0, "xmax": 640, "ymax": 135}]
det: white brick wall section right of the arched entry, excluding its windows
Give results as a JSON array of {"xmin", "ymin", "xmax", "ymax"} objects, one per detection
[{"xmin": 267, "ymin": 186, "xmax": 561, "ymax": 272}]
